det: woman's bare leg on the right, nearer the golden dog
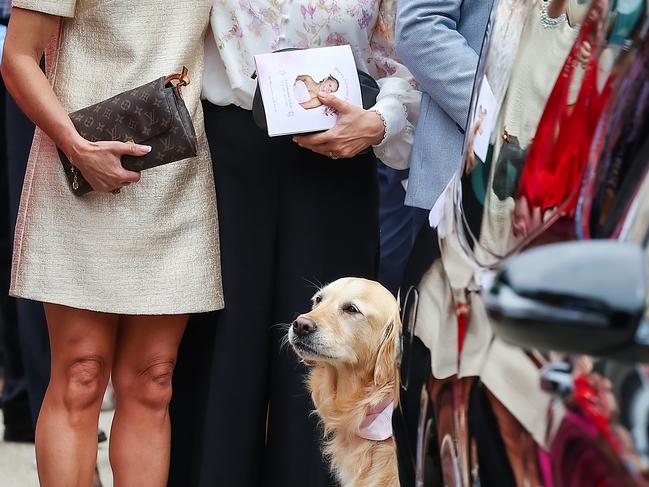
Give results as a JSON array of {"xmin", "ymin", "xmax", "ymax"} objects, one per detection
[{"xmin": 110, "ymin": 316, "xmax": 188, "ymax": 487}]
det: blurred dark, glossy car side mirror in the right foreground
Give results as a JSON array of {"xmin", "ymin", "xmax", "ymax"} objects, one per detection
[{"xmin": 483, "ymin": 240, "xmax": 649, "ymax": 362}]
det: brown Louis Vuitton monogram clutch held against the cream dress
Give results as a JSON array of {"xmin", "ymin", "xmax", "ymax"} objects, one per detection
[{"xmin": 59, "ymin": 67, "xmax": 197, "ymax": 196}]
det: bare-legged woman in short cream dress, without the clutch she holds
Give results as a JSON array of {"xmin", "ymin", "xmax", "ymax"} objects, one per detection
[{"xmin": 2, "ymin": 0, "xmax": 223, "ymax": 487}]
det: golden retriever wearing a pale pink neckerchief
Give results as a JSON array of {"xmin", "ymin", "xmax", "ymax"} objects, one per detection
[{"xmin": 288, "ymin": 278, "xmax": 401, "ymax": 487}]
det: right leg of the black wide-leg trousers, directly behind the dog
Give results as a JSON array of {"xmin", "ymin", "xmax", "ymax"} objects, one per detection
[{"xmin": 263, "ymin": 148, "xmax": 379, "ymax": 487}]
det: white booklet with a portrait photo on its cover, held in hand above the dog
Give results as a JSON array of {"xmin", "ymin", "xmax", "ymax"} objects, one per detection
[{"xmin": 255, "ymin": 46, "xmax": 363, "ymax": 137}]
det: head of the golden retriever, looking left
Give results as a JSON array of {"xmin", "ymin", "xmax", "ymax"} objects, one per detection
[{"xmin": 288, "ymin": 278, "xmax": 401, "ymax": 385}]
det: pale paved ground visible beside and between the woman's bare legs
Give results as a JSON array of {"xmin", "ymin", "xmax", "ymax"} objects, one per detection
[{"xmin": 0, "ymin": 411, "xmax": 113, "ymax": 487}]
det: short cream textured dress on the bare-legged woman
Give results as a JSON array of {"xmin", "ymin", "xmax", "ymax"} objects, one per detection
[{"xmin": 10, "ymin": 0, "xmax": 223, "ymax": 315}]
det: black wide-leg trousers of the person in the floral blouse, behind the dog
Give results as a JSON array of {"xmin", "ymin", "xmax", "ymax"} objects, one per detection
[{"xmin": 170, "ymin": 103, "xmax": 379, "ymax": 487}]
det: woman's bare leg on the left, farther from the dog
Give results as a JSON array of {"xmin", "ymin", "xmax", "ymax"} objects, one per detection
[{"xmin": 36, "ymin": 304, "xmax": 118, "ymax": 487}]
